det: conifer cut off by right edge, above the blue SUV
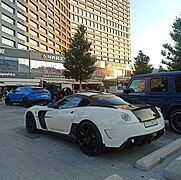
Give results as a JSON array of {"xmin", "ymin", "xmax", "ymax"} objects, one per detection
[{"xmin": 161, "ymin": 14, "xmax": 181, "ymax": 71}]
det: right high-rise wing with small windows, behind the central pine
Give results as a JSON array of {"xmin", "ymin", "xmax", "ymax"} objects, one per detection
[{"xmin": 70, "ymin": 0, "xmax": 132, "ymax": 79}]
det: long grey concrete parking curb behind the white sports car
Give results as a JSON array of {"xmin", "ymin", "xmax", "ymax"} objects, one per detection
[{"xmin": 135, "ymin": 139, "xmax": 181, "ymax": 171}]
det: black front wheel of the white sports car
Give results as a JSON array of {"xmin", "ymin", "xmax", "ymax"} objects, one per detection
[{"xmin": 25, "ymin": 112, "xmax": 37, "ymax": 133}]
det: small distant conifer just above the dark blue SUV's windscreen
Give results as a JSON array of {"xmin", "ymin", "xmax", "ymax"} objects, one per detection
[{"xmin": 133, "ymin": 50, "xmax": 153, "ymax": 75}]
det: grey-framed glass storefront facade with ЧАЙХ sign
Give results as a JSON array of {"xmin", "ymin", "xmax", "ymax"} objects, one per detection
[{"xmin": 0, "ymin": 48, "xmax": 64, "ymax": 78}]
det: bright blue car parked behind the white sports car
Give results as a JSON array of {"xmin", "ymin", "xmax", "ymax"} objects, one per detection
[{"xmin": 5, "ymin": 87, "xmax": 51, "ymax": 107}]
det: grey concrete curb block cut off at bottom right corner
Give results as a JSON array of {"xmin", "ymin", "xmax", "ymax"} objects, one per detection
[{"xmin": 164, "ymin": 156, "xmax": 181, "ymax": 180}]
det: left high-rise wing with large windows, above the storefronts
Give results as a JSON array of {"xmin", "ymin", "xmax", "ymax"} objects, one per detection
[{"xmin": 0, "ymin": 0, "xmax": 71, "ymax": 54}]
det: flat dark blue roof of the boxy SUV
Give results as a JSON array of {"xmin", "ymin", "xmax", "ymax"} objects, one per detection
[{"xmin": 133, "ymin": 71, "xmax": 181, "ymax": 77}]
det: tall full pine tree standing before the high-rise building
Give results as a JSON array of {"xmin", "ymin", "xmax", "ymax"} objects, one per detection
[{"xmin": 64, "ymin": 25, "xmax": 97, "ymax": 92}]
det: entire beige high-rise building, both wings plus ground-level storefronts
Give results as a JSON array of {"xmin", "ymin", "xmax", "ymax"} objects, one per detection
[{"xmin": 0, "ymin": 0, "xmax": 132, "ymax": 87}]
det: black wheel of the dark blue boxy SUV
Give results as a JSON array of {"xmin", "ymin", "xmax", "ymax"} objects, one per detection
[{"xmin": 169, "ymin": 109, "xmax": 181, "ymax": 134}]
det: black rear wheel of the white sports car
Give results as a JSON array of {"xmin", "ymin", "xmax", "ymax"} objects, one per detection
[{"xmin": 76, "ymin": 121, "xmax": 102, "ymax": 156}]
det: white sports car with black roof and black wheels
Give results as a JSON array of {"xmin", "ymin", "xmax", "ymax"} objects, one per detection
[{"xmin": 24, "ymin": 93, "xmax": 165, "ymax": 156}]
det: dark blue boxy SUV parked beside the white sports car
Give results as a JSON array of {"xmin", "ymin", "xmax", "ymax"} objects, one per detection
[{"xmin": 121, "ymin": 71, "xmax": 181, "ymax": 134}]
